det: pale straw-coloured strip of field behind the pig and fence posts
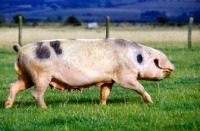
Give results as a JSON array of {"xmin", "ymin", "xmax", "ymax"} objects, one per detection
[{"xmin": 0, "ymin": 25, "xmax": 200, "ymax": 48}]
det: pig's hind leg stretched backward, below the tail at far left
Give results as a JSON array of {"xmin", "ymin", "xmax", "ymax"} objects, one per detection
[{"xmin": 4, "ymin": 76, "xmax": 33, "ymax": 108}]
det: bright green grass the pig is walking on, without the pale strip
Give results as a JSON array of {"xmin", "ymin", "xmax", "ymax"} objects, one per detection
[{"xmin": 0, "ymin": 43, "xmax": 200, "ymax": 131}]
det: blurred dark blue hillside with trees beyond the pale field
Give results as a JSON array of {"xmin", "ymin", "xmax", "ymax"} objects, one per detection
[{"xmin": 0, "ymin": 0, "xmax": 200, "ymax": 26}]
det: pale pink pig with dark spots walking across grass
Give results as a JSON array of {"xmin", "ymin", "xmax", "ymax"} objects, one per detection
[{"xmin": 4, "ymin": 38, "xmax": 174, "ymax": 108}]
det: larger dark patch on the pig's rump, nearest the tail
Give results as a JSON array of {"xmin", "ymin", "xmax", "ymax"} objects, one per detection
[{"xmin": 35, "ymin": 42, "xmax": 50, "ymax": 59}]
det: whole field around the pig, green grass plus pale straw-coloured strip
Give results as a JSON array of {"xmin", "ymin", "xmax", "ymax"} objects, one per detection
[{"xmin": 0, "ymin": 26, "xmax": 200, "ymax": 131}]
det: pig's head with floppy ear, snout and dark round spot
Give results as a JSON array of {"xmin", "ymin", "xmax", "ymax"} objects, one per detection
[{"xmin": 135, "ymin": 46, "xmax": 174, "ymax": 80}]
